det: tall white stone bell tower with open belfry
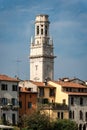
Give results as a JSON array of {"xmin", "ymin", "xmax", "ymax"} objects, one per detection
[{"xmin": 30, "ymin": 14, "xmax": 55, "ymax": 82}]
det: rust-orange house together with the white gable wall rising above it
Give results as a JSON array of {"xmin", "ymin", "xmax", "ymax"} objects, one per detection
[{"xmin": 19, "ymin": 80, "xmax": 37, "ymax": 118}]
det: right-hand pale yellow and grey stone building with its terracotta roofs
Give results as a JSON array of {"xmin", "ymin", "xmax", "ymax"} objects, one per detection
[{"xmin": 49, "ymin": 79, "xmax": 87, "ymax": 130}]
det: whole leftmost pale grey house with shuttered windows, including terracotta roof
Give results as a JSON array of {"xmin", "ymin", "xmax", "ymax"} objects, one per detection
[{"xmin": 0, "ymin": 75, "xmax": 19, "ymax": 125}]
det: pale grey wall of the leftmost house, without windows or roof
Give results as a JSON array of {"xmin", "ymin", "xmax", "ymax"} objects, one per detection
[{"xmin": 0, "ymin": 81, "xmax": 19, "ymax": 124}]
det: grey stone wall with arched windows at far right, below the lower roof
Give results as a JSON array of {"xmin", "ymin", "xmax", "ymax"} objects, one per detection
[{"xmin": 69, "ymin": 96, "xmax": 87, "ymax": 130}]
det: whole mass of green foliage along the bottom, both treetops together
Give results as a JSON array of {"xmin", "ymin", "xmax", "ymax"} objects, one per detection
[{"xmin": 21, "ymin": 112, "xmax": 78, "ymax": 130}]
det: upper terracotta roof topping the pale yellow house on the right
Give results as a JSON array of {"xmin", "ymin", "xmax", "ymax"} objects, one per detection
[{"xmin": 53, "ymin": 81, "xmax": 87, "ymax": 88}]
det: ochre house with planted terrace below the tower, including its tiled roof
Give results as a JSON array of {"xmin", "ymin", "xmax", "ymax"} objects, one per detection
[{"xmin": 28, "ymin": 81, "xmax": 69, "ymax": 120}]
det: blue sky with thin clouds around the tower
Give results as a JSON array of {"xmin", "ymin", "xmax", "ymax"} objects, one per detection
[{"xmin": 0, "ymin": 0, "xmax": 87, "ymax": 80}]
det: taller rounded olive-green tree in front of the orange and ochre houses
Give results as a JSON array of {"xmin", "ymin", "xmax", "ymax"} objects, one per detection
[{"xmin": 27, "ymin": 112, "xmax": 50, "ymax": 130}]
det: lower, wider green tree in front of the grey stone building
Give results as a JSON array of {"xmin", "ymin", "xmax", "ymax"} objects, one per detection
[{"xmin": 52, "ymin": 119, "xmax": 78, "ymax": 130}]
